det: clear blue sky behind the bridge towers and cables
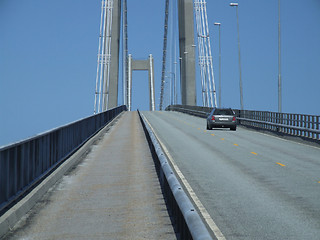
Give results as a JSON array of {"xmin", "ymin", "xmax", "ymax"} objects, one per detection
[{"xmin": 0, "ymin": 0, "xmax": 320, "ymax": 146}]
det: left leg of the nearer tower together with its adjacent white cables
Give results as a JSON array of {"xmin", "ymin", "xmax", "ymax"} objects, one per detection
[{"xmin": 94, "ymin": 0, "xmax": 121, "ymax": 113}]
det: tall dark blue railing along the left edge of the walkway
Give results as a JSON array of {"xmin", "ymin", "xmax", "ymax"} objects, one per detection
[{"xmin": 0, "ymin": 106, "xmax": 127, "ymax": 216}]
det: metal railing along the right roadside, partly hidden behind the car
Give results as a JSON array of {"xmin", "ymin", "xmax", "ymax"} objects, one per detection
[{"xmin": 166, "ymin": 105, "xmax": 320, "ymax": 140}]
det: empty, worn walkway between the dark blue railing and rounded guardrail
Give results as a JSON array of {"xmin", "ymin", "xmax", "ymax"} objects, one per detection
[{"xmin": 7, "ymin": 112, "xmax": 176, "ymax": 239}]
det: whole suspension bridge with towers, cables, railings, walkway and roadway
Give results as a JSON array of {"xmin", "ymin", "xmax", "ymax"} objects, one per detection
[{"xmin": 0, "ymin": 0, "xmax": 320, "ymax": 239}]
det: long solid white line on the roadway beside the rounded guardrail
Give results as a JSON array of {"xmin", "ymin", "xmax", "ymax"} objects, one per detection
[{"xmin": 144, "ymin": 114, "xmax": 226, "ymax": 240}]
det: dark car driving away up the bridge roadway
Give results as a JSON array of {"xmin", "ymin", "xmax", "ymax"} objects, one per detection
[{"xmin": 207, "ymin": 108, "xmax": 237, "ymax": 131}]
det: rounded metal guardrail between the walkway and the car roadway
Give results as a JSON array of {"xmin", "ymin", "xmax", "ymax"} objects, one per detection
[{"xmin": 139, "ymin": 113, "xmax": 212, "ymax": 240}]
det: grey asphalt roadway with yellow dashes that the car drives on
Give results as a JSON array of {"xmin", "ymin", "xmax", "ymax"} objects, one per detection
[{"xmin": 143, "ymin": 112, "xmax": 320, "ymax": 239}]
